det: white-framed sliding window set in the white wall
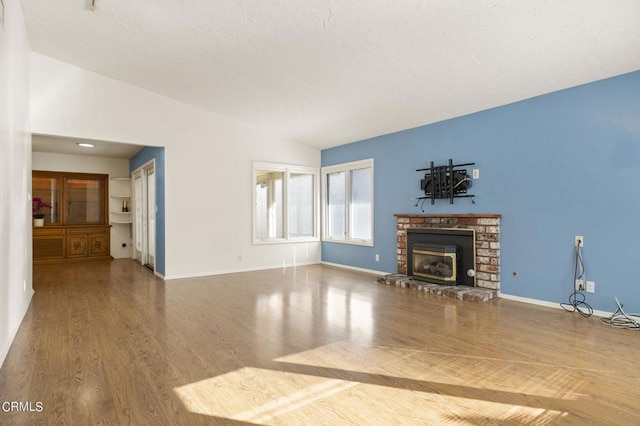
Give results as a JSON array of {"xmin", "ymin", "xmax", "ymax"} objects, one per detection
[{"xmin": 253, "ymin": 163, "xmax": 319, "ymax": 244}]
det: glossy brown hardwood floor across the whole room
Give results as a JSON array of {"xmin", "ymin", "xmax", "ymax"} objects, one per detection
[{"xmin": 0, "ymin": 260, "xmax": 640, "ymax": 425}]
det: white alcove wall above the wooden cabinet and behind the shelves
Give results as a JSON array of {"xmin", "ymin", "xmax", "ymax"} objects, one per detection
[{"xmin": 32, "ymin": 153, "xmax": 133, "ymax": 259}]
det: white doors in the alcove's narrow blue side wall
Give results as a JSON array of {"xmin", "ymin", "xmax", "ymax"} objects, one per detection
[{"xmin": 132, "ymin": 160, "xmax": 157, "ymax": 271}]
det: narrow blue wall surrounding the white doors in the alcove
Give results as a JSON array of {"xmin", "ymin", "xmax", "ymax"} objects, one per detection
[{"xmin": 129, "ymin": 147, "xmax": 166, "ymax": 275}]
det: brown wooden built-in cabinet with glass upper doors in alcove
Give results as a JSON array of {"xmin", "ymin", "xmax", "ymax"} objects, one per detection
[{"xmin": 33, "ymin": 171, "xmax": 111, "ymax": 263}]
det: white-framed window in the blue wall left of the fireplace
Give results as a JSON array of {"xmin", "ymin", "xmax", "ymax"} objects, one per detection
[{"xmin": 322, "ymin": 159, "xmax": 373, "ymax": 246}]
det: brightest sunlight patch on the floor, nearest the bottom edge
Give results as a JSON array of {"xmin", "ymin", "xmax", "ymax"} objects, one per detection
[{"xmin": 174, "ymin": 367, "xmax": 565, "ymax": 424}]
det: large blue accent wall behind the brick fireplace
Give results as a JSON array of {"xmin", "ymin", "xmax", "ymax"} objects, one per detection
[{"xmin": 322, "ymin": 72, "xmax": 640, "ymax": 312}]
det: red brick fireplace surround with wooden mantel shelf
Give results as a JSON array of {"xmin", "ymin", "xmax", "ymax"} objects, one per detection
[{"xmin": 394, "ymin": 213, "xmax": 502, "ymax": 290}]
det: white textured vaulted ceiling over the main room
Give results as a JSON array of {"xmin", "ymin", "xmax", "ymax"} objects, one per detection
[{"xmin": 22, "ymin": 0, "xmax": 640, "ymax": 148}]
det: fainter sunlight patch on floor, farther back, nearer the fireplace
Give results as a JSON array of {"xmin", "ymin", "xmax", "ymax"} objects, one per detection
[{"xmin": 275, "ymin": 342, "xmax": 605, "ymax": 400}]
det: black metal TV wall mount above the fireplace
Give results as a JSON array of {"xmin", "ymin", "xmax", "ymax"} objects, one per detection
[{"xmin": 416, "ymin": 159, "xmax": 476, "ymax": 204}]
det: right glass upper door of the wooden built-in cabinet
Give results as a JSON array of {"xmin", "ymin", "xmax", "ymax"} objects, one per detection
[{"xmin": 64, "ymin": 178, "xmax": 105, "ymax": 224}]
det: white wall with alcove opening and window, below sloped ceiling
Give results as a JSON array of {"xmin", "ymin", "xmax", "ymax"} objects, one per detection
[{"xmin": 31, "ymin": 54, "xmax": 320, "ymax": 278}]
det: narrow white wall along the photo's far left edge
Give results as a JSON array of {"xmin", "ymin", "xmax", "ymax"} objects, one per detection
[{"xmin": 0, "ymin": 0, "xmax": 33, "ymax": 366}]
